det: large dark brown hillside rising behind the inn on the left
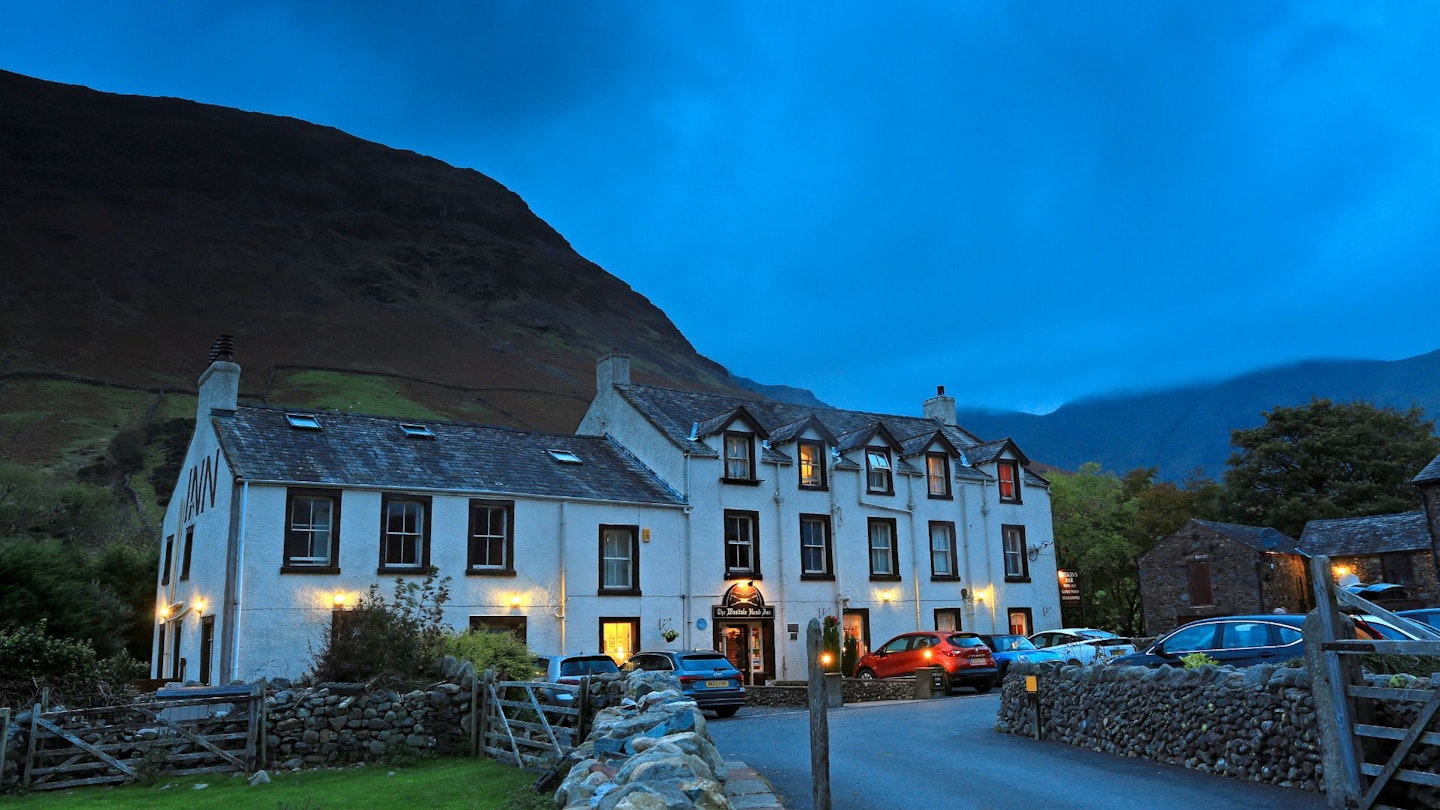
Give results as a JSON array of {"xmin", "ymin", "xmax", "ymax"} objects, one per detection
[{"xmin": 0, "ymin": 72, "xmax": 777, "ymax": 468}]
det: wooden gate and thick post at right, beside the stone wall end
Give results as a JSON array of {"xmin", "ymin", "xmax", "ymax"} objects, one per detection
[{"xmin": 1306, "ymin": 556, "xmax": 1440, "ymax": 810}]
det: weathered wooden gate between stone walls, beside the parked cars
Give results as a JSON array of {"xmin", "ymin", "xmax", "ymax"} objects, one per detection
[{"xmin": 477, "ymin": 672, "xmax": 590, "ymax": 773}]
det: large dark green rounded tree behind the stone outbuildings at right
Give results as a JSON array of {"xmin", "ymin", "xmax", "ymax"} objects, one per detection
[{"xmin": 1224, "ymin": 399, "xmax": 1440, "ymax": 538}]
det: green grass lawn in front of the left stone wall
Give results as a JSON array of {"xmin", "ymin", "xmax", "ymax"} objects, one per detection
[{"xmin": 0, "ymin": 760, "xmax": 553, "ymax": 810}]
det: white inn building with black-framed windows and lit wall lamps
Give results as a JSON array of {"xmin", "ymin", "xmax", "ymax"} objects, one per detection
[{"xmin": 153, "ymin": 346, "xmax": 1060, "ymax": 683}]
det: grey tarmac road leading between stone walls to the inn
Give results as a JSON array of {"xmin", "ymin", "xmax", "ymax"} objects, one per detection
[{"xmin": 707, "ymin": 695, "xmax": 1326, "ymax": 810}]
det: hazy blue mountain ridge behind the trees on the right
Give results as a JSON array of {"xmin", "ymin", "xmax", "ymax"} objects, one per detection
[{"xmin": 959, "ymin": 350, "xmax": 1440, "ymax": 481}]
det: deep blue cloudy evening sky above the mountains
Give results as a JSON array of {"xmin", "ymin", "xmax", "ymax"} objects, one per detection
[{"xmin": 0, "ymin": 0, "xmax": 1440, "ymax": 414}]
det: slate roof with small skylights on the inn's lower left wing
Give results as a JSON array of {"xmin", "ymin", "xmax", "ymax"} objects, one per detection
[{"xmin": 210, "ymin": 406, "xmax": 684, "ymax": 506}]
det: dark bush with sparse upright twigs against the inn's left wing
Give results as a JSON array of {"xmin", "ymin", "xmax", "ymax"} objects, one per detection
[{"xmin": 311, "ymin": 568, "xmax": 449, "ymax": 682}]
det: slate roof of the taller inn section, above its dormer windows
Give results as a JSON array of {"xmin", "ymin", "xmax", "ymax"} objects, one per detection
[{"xmin": 615, "ymin": 385, "xmax": 1050, "ymax": 486}]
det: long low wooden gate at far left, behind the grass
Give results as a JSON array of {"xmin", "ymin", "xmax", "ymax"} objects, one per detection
[{"xmin": 20, "ymin": 685, "xmax": 265, "ymax": 790}]
